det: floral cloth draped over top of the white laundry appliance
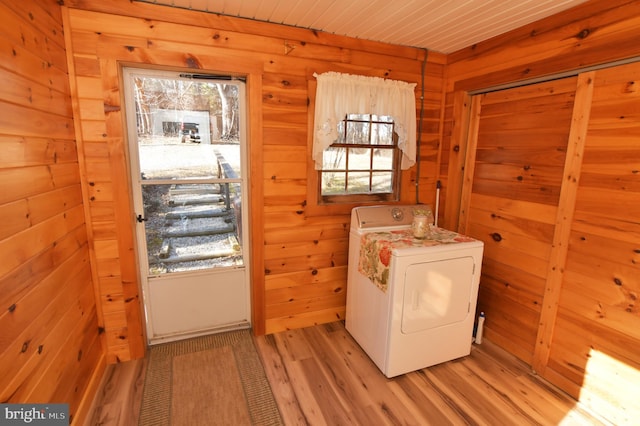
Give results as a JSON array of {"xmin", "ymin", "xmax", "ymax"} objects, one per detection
[{"xmin": 358, "ymin": 228, "xmax": 475, "ymax": 292}]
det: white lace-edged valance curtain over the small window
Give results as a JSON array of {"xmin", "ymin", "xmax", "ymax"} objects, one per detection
[{"xmin": 313, "ymin": 72, "xmax": 416, "ymax": 170}]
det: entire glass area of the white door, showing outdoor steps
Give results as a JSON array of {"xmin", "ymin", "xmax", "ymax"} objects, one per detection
[{"xmin": 131, "ymin": 75, "xmax": 243, "ymax": 275}]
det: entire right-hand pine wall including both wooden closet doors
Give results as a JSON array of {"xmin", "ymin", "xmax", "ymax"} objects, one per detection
[{"xmin": 443, "ymin": 0, "xmax": 640, "ymax": 424}]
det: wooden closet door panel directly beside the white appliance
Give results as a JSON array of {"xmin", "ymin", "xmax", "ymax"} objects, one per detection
[{"xmin": 459, "ymin": 77, "xmax": 577, "ymax": 364}]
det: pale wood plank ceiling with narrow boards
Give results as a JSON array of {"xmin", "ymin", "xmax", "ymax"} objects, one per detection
[{"xmin": 137, "ymin": 0, "xmax": 587, "ymax": 53}]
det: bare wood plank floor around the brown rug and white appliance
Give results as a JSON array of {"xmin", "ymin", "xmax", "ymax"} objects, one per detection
[{"xmin": 86, "ymin": 322, "xmax": 603, "ymax": 426}]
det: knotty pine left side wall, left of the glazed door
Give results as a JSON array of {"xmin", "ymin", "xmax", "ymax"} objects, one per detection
[{"xmin": 0, "ymin": 0, "xmax": 105, "ymax": 418}]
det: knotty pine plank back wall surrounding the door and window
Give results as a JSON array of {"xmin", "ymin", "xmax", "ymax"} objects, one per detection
[{"xmin": 65, "ymin": 0, "xmax": 445, "ymax": 362}]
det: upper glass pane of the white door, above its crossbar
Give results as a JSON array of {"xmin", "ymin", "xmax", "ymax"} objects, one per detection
[{"xmin": 132, "ymin": 76, "xmax": 242, "ymax": 179}]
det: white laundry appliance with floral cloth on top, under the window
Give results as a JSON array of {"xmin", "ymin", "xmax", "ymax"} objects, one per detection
[{"xmin": 345, "ymin": 205, "xmax": 484, "ymax": 377}]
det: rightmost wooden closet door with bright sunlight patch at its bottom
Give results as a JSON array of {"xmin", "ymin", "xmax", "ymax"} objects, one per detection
[{"xmin": 538, "ymin": 63, "xmax": 640, "ymax": 425}]
